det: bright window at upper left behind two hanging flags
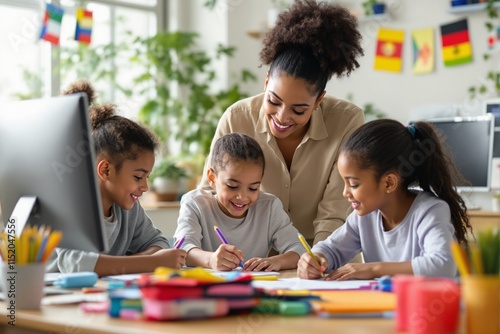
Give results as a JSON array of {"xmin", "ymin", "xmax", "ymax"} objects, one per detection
[{"xmin": 0, "ymin": 0, "xmax": 164, "ymax": 114}]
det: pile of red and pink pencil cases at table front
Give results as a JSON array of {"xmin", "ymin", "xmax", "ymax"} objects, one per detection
[{"xmin": 137, "ymin": 267, "xmax": 258, "ymax": 320}]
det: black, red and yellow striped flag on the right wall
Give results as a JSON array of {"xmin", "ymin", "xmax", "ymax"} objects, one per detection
[{"xmin": 441, "ymin": 19, "xmax": 472, "ymax": 66}]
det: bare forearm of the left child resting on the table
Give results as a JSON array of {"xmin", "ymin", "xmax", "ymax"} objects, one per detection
[{"xmin": 94, "ymin": 254, "xmax": 161, "ymax": 277}]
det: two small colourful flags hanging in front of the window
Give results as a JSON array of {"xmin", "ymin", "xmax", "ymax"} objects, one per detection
[{"xmin": 40, "ymin": 3, "xmax": 93, "ymax": 45}]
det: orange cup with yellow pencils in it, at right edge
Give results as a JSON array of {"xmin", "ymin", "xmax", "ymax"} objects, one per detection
[{"xmin": 452, "ymin": 228, "xmax": 500, "ymax": 334}]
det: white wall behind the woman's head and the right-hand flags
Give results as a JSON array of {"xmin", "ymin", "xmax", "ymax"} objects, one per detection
[{"xmin": 226, "ymin": 0, "xmax": 498, "ymax": 122}]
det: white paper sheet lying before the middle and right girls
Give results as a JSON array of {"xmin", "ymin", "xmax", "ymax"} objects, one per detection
[{"xmin": 252, "ymin": 277, "xmax": 375, "ymax": 290}]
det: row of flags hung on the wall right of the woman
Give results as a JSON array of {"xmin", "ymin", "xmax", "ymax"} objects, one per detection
[{"xmin": 373, "ymin": 19, "xmax": 500, "ymax": 74}]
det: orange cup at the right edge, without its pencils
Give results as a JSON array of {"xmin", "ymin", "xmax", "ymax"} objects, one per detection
[{"xmin": 462, "ymin": 275, "xmax": 500, "ymax": 334}]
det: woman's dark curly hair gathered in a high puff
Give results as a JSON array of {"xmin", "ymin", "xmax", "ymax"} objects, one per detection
[{"xmin": 259, "ymin": 0, "xmax": 364, "ymax": 95}]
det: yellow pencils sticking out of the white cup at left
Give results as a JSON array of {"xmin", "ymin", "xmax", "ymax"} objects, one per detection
[{"xmin": 0, "ymin": 225, "xmax": 63, "ymax": 264}]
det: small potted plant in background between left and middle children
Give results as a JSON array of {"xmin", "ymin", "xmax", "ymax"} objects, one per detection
[{"xmin": 151, "ymin": 158, "xmax": 188, "ymax": 201}]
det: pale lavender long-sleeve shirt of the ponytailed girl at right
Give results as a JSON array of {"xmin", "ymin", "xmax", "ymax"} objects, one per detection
[{"xmin": 312, "ymin": 191, "xmax": 457, "ymax": 277}]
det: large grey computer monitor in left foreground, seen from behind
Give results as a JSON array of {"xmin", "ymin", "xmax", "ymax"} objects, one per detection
[{"xmin": 0, "ymin": 93, "xmax": 107, "ymax": 252}]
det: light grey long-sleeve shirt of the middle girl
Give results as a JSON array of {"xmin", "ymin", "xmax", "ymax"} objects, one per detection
[{"xmin": 174, "ymin": 189, "xmax": 305, "ymax": 260}]
